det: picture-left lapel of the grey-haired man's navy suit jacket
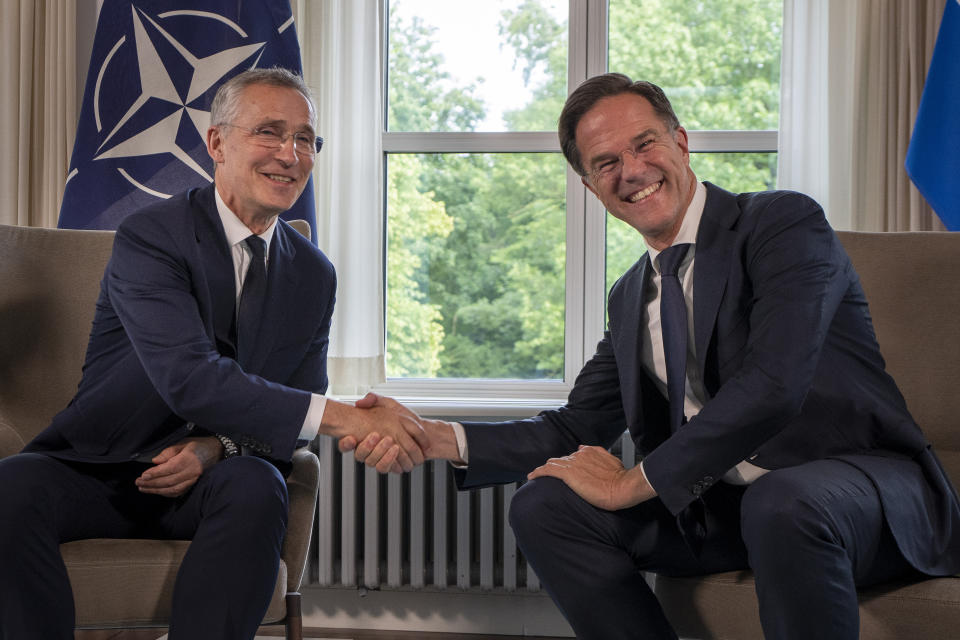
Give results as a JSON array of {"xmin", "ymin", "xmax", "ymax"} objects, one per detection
[{"xmin": 193, "ymin": 184, "xmax": 237, "ymax": 358}]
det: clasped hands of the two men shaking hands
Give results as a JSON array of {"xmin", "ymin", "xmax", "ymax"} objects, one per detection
[{"xmin": 320, "ymin": 393, "xmax": 463, "ymax": 473}]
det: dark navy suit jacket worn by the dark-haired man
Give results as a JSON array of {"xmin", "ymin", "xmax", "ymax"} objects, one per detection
[{"xmin": 458, "ymin": 183, "xmax": 960, "ymax": 574}]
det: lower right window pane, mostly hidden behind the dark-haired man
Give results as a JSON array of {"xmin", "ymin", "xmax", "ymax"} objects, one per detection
[{"xmin": 606, "ymin": 153, "xmax": 777, "ymax": 291}]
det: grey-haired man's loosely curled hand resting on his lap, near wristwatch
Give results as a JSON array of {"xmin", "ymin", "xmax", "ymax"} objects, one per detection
[{"xmin": 136, "ymin": 436, "xmax": 223, "ymax": 498}]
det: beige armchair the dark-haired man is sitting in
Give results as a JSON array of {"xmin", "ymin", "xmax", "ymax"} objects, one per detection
[{"xmin": 655, "ymin": 232, "xmax": 960, "ymax": 640}]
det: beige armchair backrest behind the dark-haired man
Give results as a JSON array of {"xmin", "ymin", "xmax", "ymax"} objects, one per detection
[{"xmin": 837, "ymin": 231, "xmax": 960, "ymax": 484}]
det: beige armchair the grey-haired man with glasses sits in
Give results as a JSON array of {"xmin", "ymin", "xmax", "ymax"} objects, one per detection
[{"xmin": 0, "ymin": 221, "xmax": 319, "ymax": 640}]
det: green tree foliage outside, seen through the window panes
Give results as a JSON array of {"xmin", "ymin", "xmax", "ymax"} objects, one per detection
[{"xmin": 387, "ymin": 0, "xmax": 780, "ymax": 379}]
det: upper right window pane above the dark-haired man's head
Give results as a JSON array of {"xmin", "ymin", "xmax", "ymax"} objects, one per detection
[{"xmin": 609, "ymin": 0, "xmax": 783, "ymax": 130}]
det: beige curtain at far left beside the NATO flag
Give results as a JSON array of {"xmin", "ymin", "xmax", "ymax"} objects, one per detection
[{"xmin": 0, "ymin": 0, "xmax": 79, "ymax": 227}]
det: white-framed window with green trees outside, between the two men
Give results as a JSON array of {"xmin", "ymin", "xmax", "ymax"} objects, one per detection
[{"xmin": 382, "ymin": 0, "xmax": 781, "ymax": 400}]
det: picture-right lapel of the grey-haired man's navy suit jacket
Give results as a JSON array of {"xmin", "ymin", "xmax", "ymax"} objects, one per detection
[{"xmin": 247, "ymin": 219, "xmax": 300, "ymax": 373}]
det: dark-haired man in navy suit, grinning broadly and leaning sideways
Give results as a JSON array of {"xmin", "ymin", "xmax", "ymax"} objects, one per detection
[{"xmin": 341, "ymin": 74, "xmax": 960, "ymax": 640}]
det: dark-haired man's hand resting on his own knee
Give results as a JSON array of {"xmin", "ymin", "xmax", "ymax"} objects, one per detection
[{"xmin": 527, "ymin": 445, "xmax": 657, "ymax": 511}]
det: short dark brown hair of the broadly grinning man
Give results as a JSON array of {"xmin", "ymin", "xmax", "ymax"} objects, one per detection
[{"xmin": 557, "ymin": 73, "xmax": 680, "ymax": 176}]
